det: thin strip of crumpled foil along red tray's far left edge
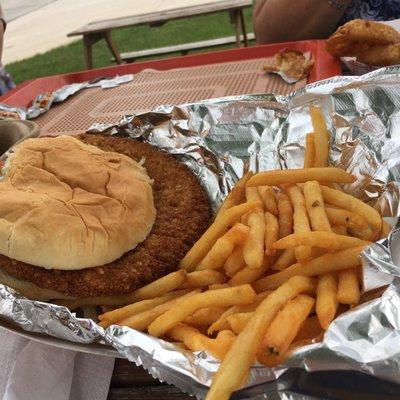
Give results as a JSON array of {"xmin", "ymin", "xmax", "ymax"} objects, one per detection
[{"xmin": 0, "ymin": 74, "xmax": 133, "ymax": 119}]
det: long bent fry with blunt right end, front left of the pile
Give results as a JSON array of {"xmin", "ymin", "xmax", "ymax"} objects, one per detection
[{"xmin": 148, "ymin": 285, "xmax": 256, "ymax": 337}]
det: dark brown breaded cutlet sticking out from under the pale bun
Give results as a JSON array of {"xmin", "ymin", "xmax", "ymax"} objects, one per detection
[{"xmin": 0, "ymin": 135, "xmax": 210, "ymax": 298}]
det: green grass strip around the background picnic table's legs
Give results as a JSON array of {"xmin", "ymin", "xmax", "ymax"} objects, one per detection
[{"xmin": 6, "ymin": 8, "xmax": 253, "ymax": 84}]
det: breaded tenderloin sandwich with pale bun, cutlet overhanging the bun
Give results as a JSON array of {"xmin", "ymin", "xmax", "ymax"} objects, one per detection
[{"xmin": 0, "ymin": 135, "xmax": 211, "ymax": 309}]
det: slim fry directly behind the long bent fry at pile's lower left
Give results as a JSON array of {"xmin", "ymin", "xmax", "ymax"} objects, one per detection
[{"xmin": 117, "ymin": 289, "xmax": 200, "ymax": 331}]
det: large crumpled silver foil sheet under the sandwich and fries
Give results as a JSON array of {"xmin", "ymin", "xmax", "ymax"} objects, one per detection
[{"xmin": 0, "ymin": 67, "xmax": 400, "ymax": 399}]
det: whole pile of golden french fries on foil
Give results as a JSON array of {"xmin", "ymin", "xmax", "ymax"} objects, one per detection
[{"xmin": 99, "ymin": 107, "xmax": 390, "ymax": 400}]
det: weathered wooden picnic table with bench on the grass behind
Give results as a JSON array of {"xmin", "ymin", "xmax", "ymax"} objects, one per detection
[{"xmin": 67, "ymin": 0, "xmax": 254, "ymax": 69}]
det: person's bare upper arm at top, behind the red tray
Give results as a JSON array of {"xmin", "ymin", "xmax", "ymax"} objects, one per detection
[{"xmin": 253, "ymin": 0, "xmax": 351, "ymax": 43}]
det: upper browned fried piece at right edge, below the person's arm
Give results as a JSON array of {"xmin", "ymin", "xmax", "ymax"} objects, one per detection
[{"xmin": 326, "ymin": 19, "xmax": 400, "ymax": 57}]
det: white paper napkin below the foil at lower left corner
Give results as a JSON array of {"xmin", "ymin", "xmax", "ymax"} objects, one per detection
[{"xmin": 0, "ymin": 328, "xmax": 114, "ymax": 400}]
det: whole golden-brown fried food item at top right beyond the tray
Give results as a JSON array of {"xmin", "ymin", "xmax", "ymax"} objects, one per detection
[{"xmin": 326, "ymin": 19, "xmax": 400, "ymax": 67}]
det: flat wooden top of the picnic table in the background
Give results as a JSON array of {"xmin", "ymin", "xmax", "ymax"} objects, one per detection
[{"xmin": 67, "ymin": 0, "xmax": 253, "ymax": 36}]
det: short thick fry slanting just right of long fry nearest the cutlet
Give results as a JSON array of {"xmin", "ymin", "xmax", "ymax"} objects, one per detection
[{"xmin": 196, "ymin": 223, "xmax": 250, "ymax": 271}]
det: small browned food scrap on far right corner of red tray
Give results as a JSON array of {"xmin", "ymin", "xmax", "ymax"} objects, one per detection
[{"xmin": 263, "ymin": 49, "xmax": 314, "ymax": 81}]
